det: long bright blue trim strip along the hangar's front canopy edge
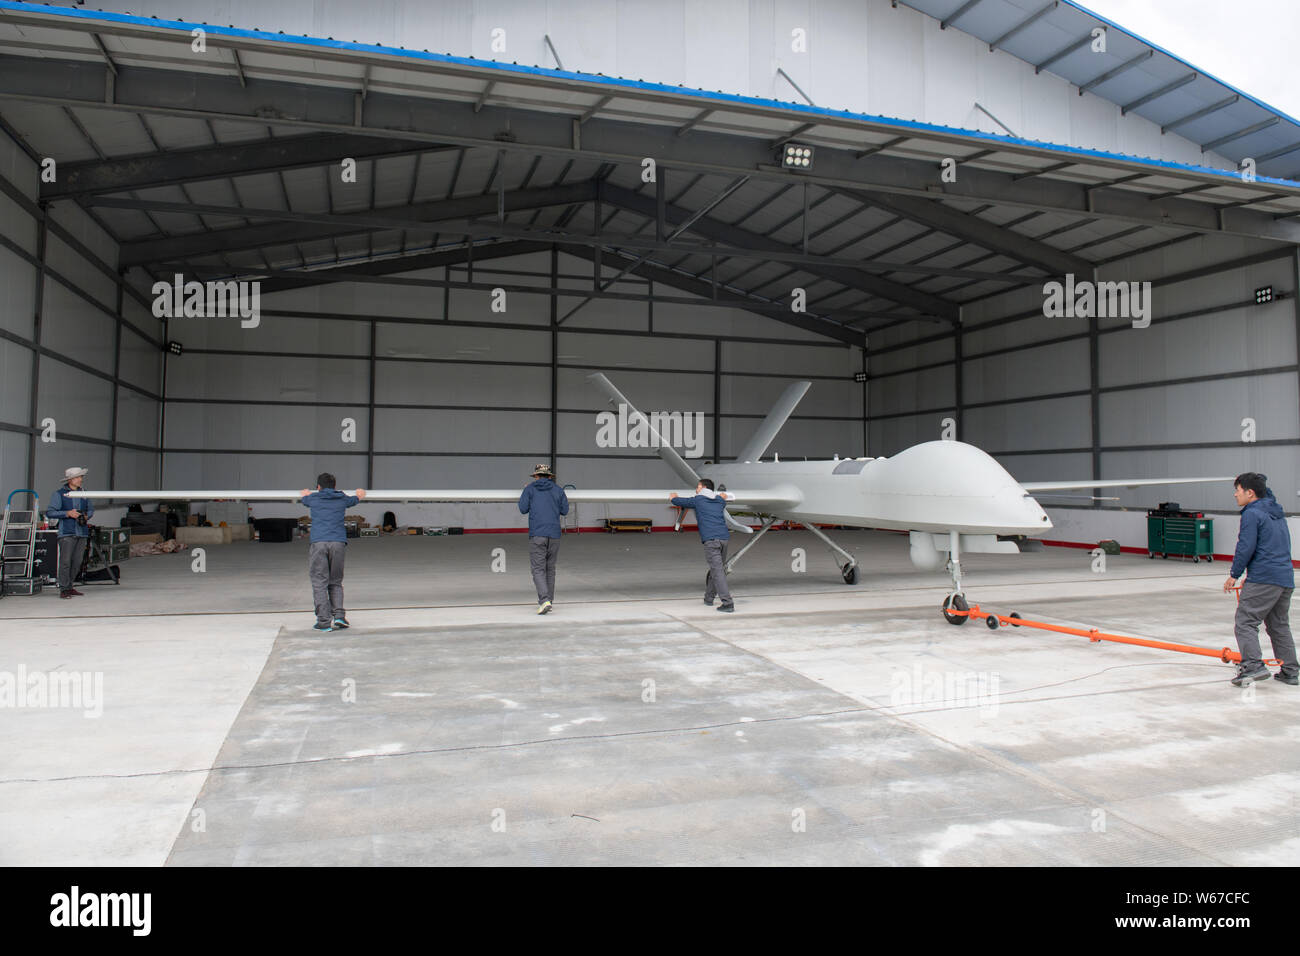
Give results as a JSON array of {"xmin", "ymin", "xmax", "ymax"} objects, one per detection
[{"xmin": 0, "ymin": 0, "xmax": 1300, "ymax": 187}]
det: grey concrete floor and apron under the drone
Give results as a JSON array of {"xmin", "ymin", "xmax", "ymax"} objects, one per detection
[{"xmin": 0, "ymin": 532, "xmax": 1300, "ymax": 865}]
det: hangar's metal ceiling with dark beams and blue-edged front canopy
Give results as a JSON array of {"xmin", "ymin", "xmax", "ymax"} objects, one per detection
[{"xmin": 0, "ymin": 0, "xmax": 1300, "ymax": 342}]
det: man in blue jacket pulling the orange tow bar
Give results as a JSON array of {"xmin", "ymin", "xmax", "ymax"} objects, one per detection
[{"xmin": 1223, "ymin": 471, "xmax": 1300, "ymax": 687}]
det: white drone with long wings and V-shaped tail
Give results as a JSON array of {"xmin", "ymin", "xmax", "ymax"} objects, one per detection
[{"xmin": 78, "ymin": 372, "xmax": 1231, "ymax": 624}]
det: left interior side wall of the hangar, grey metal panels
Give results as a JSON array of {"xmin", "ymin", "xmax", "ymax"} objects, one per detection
[{"xmin": 0, "ymin": 137, "xmax": 163, "ymax": 502}]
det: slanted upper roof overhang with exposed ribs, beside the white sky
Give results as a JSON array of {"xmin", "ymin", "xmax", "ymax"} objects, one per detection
[{"xmin": 900, "ymin": 0, "xmax": 1300, "ymax": 181}]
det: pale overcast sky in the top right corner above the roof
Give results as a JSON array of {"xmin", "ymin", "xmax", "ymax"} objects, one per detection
[{"xmin": 1078, "ymin": 0, "xmax": 1300, "ymax": 118}]
